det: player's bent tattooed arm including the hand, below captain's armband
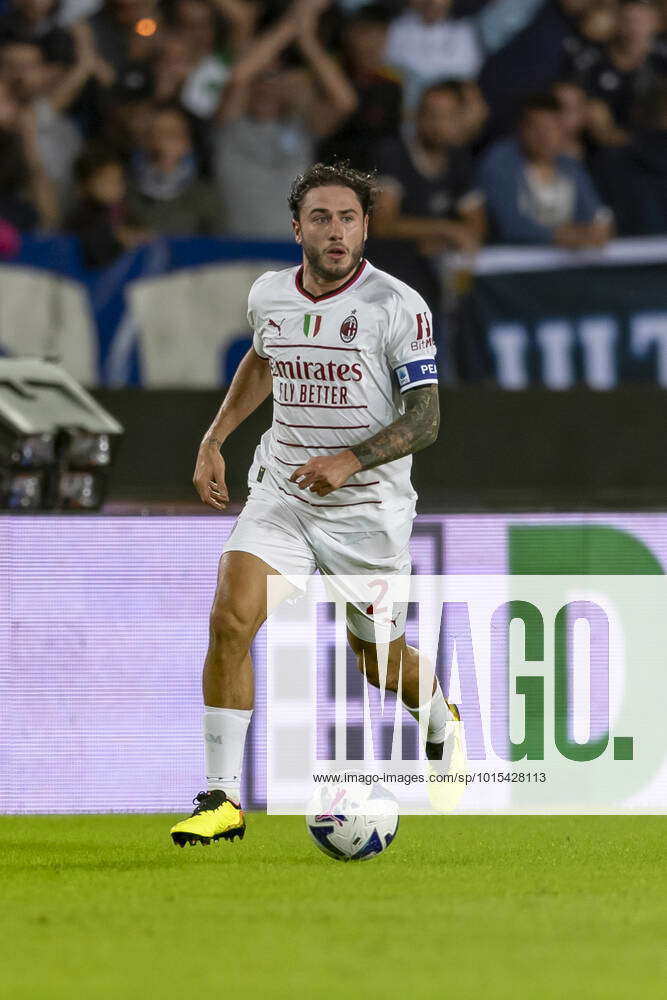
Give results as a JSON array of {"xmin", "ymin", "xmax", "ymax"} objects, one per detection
[{"xmin": 290, "ymin": 384, "xmax": 440, "ymax": 497}]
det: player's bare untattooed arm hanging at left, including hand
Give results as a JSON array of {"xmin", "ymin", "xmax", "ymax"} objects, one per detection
[{"xmin": 192, "ymin": 347, "xmax": 272, "ymax": 510}]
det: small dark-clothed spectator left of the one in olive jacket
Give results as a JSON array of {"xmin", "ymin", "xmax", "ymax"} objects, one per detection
[{"xmin": 65, "ymin": 149, "xmax": 148, "ymax": 268}]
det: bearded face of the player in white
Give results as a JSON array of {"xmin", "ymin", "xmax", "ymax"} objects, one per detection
[{"xmin": 292, "ymin": 184, "xmax": 368, "ymax": 281}]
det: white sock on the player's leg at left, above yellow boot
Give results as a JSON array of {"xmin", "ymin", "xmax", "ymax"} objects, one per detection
[{"xmin": 204, "ymin": 705, "xmax": 252, "ymax": 803}]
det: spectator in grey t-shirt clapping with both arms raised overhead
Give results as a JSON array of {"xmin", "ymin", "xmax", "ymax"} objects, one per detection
[{"xmin": 214, "ymin": 0, "xmax": 357, "ymax": 239}]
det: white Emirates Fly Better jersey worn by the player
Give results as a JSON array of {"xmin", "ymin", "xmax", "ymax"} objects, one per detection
[{"xmin": 248, "ymin": 260, "xmax": 438, "ymax": 531}]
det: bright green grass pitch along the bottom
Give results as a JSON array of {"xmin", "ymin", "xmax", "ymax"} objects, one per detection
[{"xmin": 0, "ymin": 814, "xmax": 667, "ymax": 1000}]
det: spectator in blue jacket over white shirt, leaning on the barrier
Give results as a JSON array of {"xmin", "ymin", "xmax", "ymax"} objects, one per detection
[{"xmin": 480, "ymin": 94, "xmax": 611, "ymax": 249}]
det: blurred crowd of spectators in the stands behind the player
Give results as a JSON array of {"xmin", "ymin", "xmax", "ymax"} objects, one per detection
[{"xmin": 0, "ymin": 0, "xmax": 667, "ymax": 301}]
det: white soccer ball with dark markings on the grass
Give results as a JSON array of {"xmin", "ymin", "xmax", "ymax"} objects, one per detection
[{"xmin": 306, "ymin": 781, "xmax": 399, "ymax": 861}]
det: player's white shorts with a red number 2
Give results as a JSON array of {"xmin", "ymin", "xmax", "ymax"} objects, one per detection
[{"xmin": 223, "ymin": 484, "xmax": 412, "ymax": 642}]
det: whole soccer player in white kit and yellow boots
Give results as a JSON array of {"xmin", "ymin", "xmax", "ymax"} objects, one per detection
[{"xmin": 171, "ymin": 164, "xmax": 458, "ymax": 846}]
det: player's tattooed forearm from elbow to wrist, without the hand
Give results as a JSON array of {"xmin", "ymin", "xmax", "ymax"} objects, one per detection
[{"xmin": 350, "ymin": 385, "xmax": 440, "ymax": 469}]
